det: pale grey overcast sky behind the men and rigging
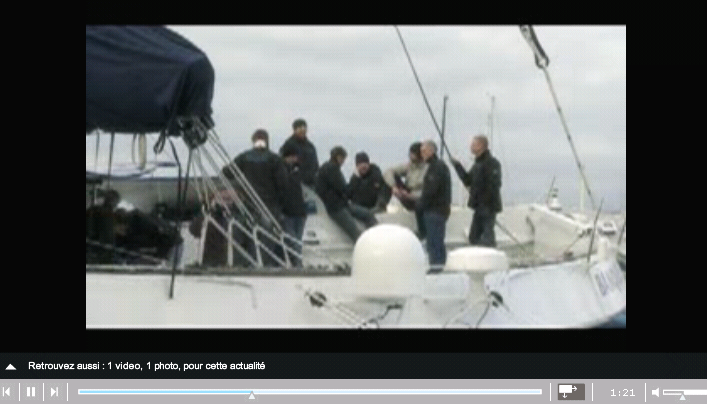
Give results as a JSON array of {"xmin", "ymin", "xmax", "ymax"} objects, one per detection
[{"xmin": 86, "ymin": 26, "xmax": 626, "ymax": 209}]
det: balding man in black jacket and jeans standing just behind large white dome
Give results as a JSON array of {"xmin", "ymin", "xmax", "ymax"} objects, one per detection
[{"xmin": 416, "ymin": 140, "xmax": 452, "ymax": 272}]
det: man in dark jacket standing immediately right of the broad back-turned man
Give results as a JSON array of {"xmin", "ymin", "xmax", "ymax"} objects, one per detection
[{"xmin": 282, "ymin": 144, "xmax": 307, "ymax": 267}]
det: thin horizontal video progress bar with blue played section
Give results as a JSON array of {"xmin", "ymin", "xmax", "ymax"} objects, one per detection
[{"xmin": 79, "ymin": 389, "xmax": 542, "ymax": 395}]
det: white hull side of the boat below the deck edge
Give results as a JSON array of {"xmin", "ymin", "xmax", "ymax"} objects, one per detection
[{"xmin": 86, "ymin": 260, "xmax": 626, "ymax": 328}]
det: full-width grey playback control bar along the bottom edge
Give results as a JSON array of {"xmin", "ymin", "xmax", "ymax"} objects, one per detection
[{"xmin": 0, "ymin": 379, "xmax": 708, "ymax": 404}]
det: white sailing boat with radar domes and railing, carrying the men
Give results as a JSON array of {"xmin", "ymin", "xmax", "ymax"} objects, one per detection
[{"xmin": 86, "ymin": 27, "xmax": 626, "ymax": 328}]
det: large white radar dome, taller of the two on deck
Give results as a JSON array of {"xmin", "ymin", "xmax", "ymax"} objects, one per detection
[{"xmin": 352, "ymin": 224, "xmax": 428, "ymax": 298}]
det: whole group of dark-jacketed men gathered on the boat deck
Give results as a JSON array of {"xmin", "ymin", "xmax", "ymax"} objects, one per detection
[{"xmin": 202, "ymin": 115, "xmax": 501, "ymax": 270}]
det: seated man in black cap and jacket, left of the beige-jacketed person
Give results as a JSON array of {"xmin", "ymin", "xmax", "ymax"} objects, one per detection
[{"xmin": 347, "ymin": 152, "xmax": 391, "ymax": 213}]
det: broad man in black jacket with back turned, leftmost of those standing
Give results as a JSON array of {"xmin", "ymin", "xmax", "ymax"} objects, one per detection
[{"xmin": 223, "ymin": 129, "xmax": 287, "ymax": 266}]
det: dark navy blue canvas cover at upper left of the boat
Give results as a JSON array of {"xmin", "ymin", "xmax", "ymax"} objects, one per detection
[{"xmin": 86, "ymin": 26, "xmax": 214, "ymax": 135}]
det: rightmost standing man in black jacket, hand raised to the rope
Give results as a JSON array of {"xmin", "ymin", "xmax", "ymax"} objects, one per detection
[{"xmin": 452, "ymin": 135, "xmax": 502, "ymax": 247}]
